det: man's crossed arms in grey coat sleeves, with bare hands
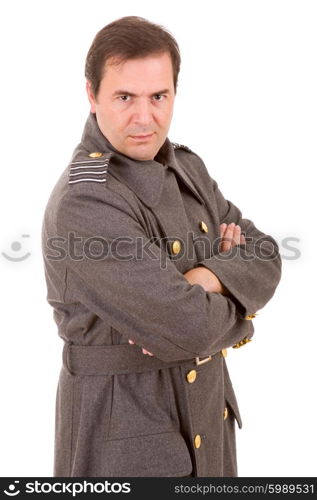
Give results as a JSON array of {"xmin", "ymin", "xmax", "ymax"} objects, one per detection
[{"xmin": 55, "ymin": 172, "xmax": 281, "ymax": 361}]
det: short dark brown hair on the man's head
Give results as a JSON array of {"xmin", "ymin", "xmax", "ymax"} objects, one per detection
[{"xmin": 85, "ymin": 16, "xmax": 181, "ymax": 97}]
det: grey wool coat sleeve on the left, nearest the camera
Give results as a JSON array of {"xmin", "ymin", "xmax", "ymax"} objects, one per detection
[{"xmin": 57, "ymin": 183, "xmax": 246, "ymax": 361}]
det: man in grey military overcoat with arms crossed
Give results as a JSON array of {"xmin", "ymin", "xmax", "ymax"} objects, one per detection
[{"xmin": 43, "ymin": 16, "xmax": 281, "ymax": 477}]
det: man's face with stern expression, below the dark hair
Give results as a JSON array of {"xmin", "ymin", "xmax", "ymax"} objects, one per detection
[{"xmin": 86, "ymin": 53, "xmax": 175, "ymax": 161}]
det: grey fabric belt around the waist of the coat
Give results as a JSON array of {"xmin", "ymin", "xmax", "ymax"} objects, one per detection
[{"xmin": 63, "ymin": 342, "xmax": 221, "ymax": 375}]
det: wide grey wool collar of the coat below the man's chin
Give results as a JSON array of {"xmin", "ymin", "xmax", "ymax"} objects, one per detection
[{"xmin": 81, "ymin": 113, "xmax": 204, "ymax": 207}]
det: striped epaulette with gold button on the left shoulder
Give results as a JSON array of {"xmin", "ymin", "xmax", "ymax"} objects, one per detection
[{"xmin": 68, "ymin": 150, "xmax": 112, "ymax": 184}]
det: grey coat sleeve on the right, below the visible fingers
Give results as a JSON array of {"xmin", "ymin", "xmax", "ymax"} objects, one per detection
[{"xmin": 198, "ymin": 178, "xmax": 281, "ymax": 317}]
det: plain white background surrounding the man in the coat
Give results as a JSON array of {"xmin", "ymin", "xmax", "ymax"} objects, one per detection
[{"xmin": 0, "ymin": 0, "xmax": 317, "ymax": 477}]
